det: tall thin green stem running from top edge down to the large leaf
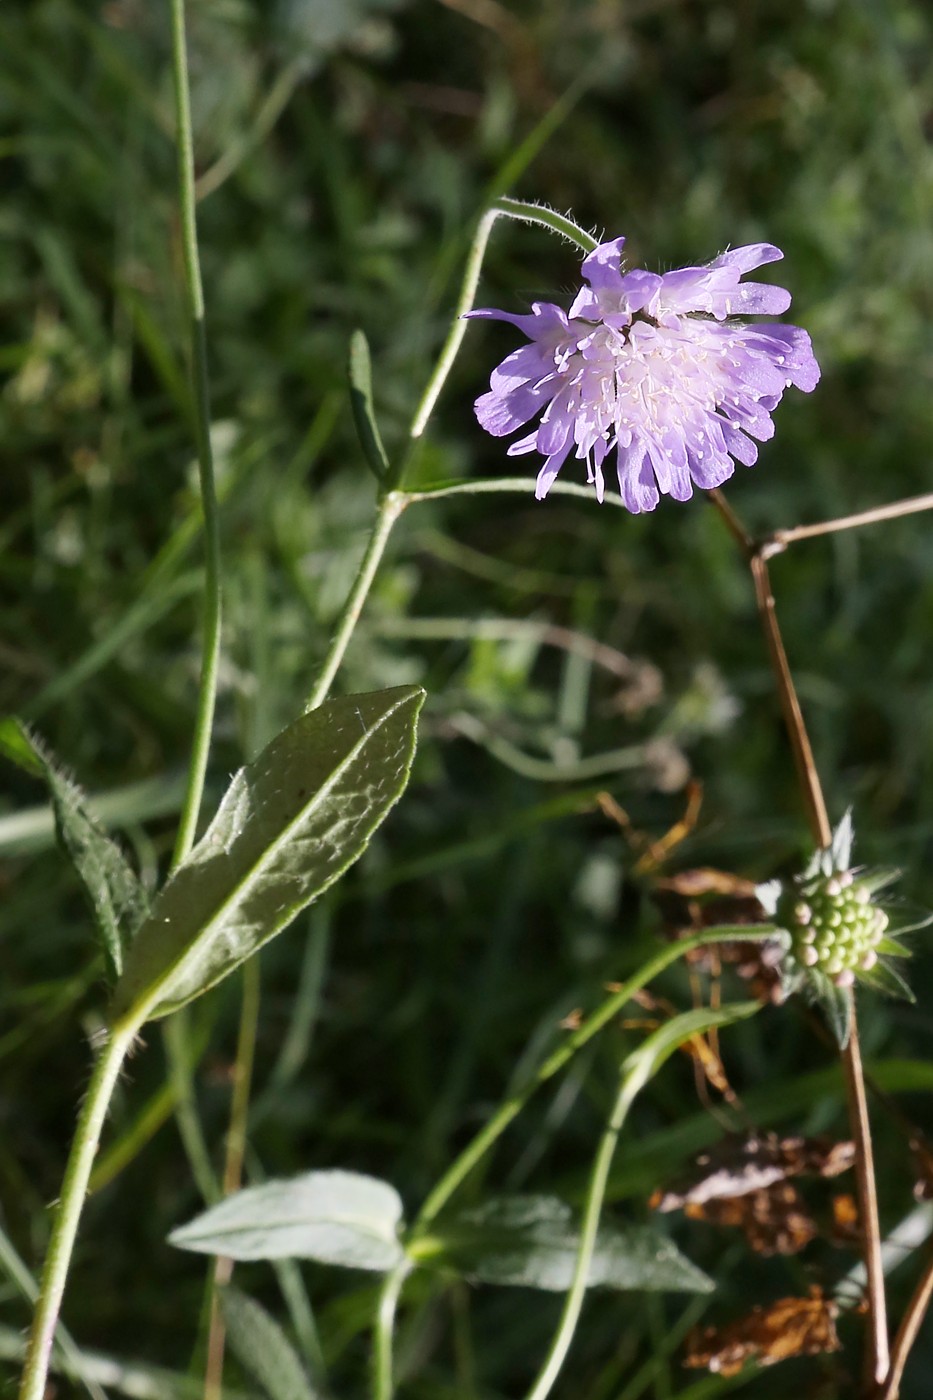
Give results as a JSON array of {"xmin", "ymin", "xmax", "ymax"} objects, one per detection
[{"xmin": 171, "ymin": 0, "xmax": 221, "ymax": 867}]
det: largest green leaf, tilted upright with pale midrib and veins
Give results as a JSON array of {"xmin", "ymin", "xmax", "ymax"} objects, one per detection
[{"xmin": 112, "ymin": 686, "xmax": 424, "ymax": 1021}]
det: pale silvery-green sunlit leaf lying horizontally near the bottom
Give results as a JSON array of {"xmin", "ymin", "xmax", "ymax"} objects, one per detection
[{"xmin": 168, "ymin": 1172, "xmax": 405, "ymax": 1273}]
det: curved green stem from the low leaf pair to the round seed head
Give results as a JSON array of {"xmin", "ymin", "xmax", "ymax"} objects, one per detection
[{"xmin": 412, "ymin": 924, "xmax": 775, "ymax": 1238}]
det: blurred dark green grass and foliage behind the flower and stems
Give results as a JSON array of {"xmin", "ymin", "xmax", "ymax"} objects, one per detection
[{"xmin": 0, "ymin": 0, "xmax": 933, "ymax": 1400}]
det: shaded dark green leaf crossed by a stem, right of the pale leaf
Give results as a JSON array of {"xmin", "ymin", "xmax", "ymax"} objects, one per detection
[{"xmin": 412, "ymin": 1196, "xmax": 714, "ymax": 1294}]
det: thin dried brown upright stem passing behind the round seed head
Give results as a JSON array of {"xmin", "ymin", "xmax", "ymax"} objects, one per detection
[{"xmin": 709, "ymin": 491, "xmax": 890, "ymax": 1386}]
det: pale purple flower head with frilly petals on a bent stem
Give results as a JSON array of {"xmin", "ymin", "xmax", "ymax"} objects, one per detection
[{"xmin": 469, "ymin": 238, "xmax": 820, "ymax": 512}]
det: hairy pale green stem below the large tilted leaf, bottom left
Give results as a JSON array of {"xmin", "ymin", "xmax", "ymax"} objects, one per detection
[{"xmin": 20, "ymin": 1021, "xmax": 139, "ymax": 1400}]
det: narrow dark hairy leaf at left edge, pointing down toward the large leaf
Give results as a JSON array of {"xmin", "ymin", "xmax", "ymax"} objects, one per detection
[{"xmin": 11, "ymin": 721, "xmax": 148, "ymax": 981}]
